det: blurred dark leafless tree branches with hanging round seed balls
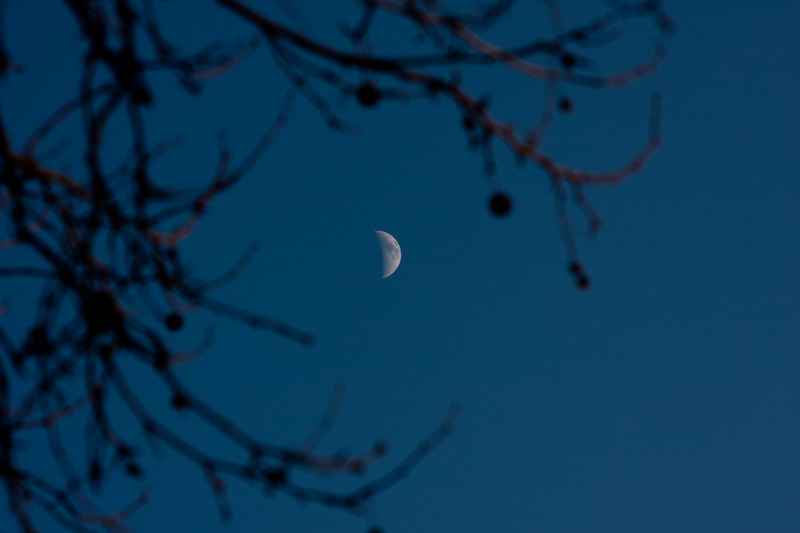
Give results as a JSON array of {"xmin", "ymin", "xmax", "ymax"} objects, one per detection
[{"xmin": 0, "ymin": 0, "xmax": 672, "ymax": 532}]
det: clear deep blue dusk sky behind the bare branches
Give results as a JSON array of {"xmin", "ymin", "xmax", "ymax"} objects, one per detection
[{"xmin": 0, "ymin": 0, "xmax": 800, "ymax": 533}]
